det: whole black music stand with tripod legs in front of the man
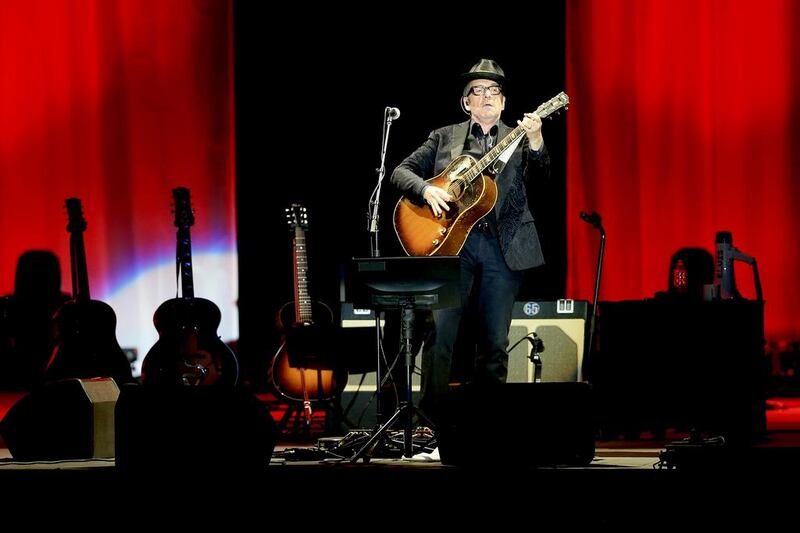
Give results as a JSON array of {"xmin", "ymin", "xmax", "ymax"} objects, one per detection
[{"xmin": 345, "ymin": 256, "xmax": 461, "ymax": 463}]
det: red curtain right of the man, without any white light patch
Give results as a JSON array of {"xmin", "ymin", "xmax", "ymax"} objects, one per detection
[{"xmin": 566, "ymin": 0, "xmax": 800, "ymax": 338}]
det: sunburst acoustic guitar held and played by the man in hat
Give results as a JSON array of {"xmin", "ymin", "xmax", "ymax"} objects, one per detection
[{"xmin": 394, "ymin": 92, "xmax": 569, "ymax": 256}]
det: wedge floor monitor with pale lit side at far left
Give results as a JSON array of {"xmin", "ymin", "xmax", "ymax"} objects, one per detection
[{"xmin": 0, "ymin": 378, "xmax": 119, "ymax": 461}]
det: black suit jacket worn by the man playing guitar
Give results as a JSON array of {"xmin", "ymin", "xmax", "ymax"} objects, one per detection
[{"xmin": 391, "ymin": 121, "xmax": 550, "ymax": 270}]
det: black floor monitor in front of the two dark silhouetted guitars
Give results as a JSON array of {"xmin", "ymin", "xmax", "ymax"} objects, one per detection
[{"xmin": 116, "ymin": 385, "xmax": 276, "ymax": 475}]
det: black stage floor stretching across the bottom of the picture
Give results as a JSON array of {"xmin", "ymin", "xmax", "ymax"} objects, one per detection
[{"xmin": 0, "ymin": 430, "xmax": 800, "ymax": 531}]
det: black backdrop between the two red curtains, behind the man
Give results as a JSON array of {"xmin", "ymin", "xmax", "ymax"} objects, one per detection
[{"xmin": 234, "ymin": 1, "xmax": 569, "ymax": 382}]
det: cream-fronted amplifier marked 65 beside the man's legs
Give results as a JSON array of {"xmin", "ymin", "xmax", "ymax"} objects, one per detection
[{"xmin": 507, "ymin": 300, "xmax": 588, "ymax": 383}]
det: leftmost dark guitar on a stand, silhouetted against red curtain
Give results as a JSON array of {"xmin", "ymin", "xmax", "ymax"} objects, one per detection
[{"xmin": 45, "ymin": 198, "xmax": 133, "ymax": 384}]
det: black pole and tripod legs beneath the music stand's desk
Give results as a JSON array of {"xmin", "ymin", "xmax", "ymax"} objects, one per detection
[{"xmin": 350, "ymin": 299, "xmax": 433, "ymax": 463}]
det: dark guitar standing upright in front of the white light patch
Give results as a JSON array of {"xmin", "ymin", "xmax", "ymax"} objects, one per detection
[{"xmin": 142, "ymin": 187, "xmax": 239, "ymax": 386}]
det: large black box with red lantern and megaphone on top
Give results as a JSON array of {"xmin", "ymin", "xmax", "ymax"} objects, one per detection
[{"xmin": 589, "ymin": 298, "xmax": 768, "ymax": 440}]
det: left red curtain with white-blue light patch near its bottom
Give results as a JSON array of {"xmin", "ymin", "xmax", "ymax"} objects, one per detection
[{"xmin": 0, "ymin": 0, "xmax": 238, "ymax": 376}]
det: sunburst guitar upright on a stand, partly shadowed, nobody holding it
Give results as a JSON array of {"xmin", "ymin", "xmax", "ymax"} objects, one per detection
[{"xmin": 270, "ymin": 204, "xmax": 345, "ymax": 424}]
